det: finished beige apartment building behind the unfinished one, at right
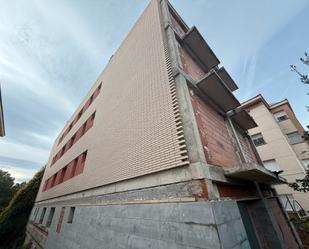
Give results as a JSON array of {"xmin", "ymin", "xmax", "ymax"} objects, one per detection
[{"xmin": 243, "ymin": 95, "xmax": 309, "ymax": 211}]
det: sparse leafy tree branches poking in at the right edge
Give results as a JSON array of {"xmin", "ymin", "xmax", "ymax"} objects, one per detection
[{"xmin": 289, "ymin": 53, "xmax": 309, "ymax": 193}]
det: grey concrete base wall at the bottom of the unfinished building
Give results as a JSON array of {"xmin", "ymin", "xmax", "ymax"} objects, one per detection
[{"xmin": 27, "ymin": 201, "xmax": 250, "ymax": 249}]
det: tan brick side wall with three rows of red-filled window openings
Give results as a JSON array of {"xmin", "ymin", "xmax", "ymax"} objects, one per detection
[{"xmin": 37, "ymin": 0, "xmax": 188, "ymax": 200}]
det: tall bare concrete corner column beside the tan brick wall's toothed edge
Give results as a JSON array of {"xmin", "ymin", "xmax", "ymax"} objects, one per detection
[{"xmin": 160, "ymin": 0, "xmax": 216, "ymax": 199}]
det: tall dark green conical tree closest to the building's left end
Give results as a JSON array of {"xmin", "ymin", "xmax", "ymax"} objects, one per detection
[{"xmin": 0, "ymin": 168, "xmax": 45, "ymax": 249}]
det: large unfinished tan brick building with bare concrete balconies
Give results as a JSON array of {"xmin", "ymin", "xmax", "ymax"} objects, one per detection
[{"xmin": 27, "ymin": 0, "xmax": 301, "ymax": 249}]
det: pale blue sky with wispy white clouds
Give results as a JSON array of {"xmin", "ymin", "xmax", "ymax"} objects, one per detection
[{"xmin": 0, "ymin": 0, "xmax": 309, "ymax": 182}]
